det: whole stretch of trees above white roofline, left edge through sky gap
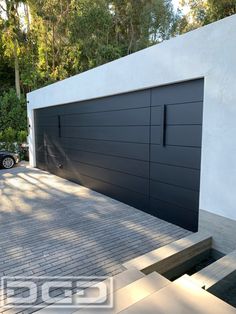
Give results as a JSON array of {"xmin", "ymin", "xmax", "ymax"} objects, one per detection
[{"xmin": 0, "ymin": 0, "xmax": 178, "ymax": 94}]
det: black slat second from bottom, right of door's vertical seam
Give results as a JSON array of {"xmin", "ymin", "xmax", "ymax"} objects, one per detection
[{"xmin": 150, "ymin": 180, "xmax": 199, "ymax": 210}]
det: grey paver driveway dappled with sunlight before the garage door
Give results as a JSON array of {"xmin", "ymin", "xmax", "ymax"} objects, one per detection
[{"xmin": 0, "ymin": 165, "xmax": 189, "ymax": 310}]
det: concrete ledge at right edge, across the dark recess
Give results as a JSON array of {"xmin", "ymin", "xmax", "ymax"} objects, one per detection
[{"xmin": 191, "ymin": 250, "xmax": 236, "ymax": 293}]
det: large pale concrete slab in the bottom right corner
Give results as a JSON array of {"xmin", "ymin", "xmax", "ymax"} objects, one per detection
[{"xmin": 120, "ymin": 275, "xmax": 236, "ymax": 314}]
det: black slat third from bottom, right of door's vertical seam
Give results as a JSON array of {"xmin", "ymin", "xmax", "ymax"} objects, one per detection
[{"xmin": 150, "ymin": 163, "xmax": 200, "ymax": 191}]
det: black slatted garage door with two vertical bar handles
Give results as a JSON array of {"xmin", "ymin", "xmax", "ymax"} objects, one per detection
[{"xmin": 35, "ymin": 80, "xmax": 203, "ymax": 231}]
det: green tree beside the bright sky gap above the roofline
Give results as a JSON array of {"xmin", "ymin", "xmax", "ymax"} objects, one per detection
[{"xmin": 112, "ymin": 0, "xmax": 177, "ymax": 53}]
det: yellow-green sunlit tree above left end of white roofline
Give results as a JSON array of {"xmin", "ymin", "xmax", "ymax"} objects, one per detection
[{"xmin": 30, "ymin": 0, "xmax": 79, "ymax": 85}]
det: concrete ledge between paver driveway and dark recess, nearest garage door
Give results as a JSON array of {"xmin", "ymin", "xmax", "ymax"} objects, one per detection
[{"xmin": 123, "ymin": 233, "xmax": 212, "ymax": 275}]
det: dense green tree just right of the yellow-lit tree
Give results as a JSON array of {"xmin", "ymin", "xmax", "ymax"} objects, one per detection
[{"xmin": 70, "ymin": 0, "xmax": 122, "ymax": 72}]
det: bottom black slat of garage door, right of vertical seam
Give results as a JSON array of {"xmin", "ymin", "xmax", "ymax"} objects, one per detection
[{"xmin": 148, "ymin": 198, "xmax": 198, "ymax": 232}]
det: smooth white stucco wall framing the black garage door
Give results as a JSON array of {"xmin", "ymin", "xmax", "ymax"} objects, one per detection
[{"xmin": 28, "ymin": 15, "xmax": 236, "ymax": 220}]
